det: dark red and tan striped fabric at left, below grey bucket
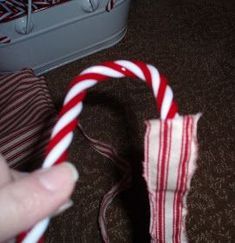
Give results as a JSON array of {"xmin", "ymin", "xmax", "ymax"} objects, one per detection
[{"xmin": 0, "ymin": 69, "xmax": 56, "ymax": 168}]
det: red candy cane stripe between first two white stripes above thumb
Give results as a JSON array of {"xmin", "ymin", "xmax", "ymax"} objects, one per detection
[{"xmin": 46, "ymin": 119, "xmax": 78, "ymax": 154}]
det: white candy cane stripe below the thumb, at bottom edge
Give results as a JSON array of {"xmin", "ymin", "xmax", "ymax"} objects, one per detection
[{"xmin": 22, "ymin": 218, "xmax": 50, "ymax": 243}]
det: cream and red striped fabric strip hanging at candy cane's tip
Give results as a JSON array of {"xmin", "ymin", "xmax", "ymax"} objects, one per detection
[{"xmin": 144, "ymin": 114, "xmax": 200, "ymax": 243}]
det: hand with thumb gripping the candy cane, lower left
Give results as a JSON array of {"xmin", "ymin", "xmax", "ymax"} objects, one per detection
[{"xmin": 0, "ymin": 156, "xmax": 78, "ymax": 242}]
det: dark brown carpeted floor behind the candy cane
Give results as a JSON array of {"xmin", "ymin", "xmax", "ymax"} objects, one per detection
[{"xmin": 43, "ymin": 0, "xmax": 235, "ymax": 243}]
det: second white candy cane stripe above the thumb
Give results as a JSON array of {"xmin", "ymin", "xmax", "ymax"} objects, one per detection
[{"xmin": 51, "ymin": 102, "xmax": 83, "ymax": 138}]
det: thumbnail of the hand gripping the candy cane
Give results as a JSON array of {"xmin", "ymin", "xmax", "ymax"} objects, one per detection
[{"xmin": 38, "ymin": 162, "xmax": 79, "ymax": 191}]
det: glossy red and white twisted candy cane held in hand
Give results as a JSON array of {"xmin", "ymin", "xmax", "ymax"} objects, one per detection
[{"xmin": 18, "ymin": 60, "xmax": 178, "ymax": 243}]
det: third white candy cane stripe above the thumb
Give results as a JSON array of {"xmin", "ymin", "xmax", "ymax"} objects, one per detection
[{"xmin": 64, "ymin": 79, "xmax": 97, "ymax": 105}]
